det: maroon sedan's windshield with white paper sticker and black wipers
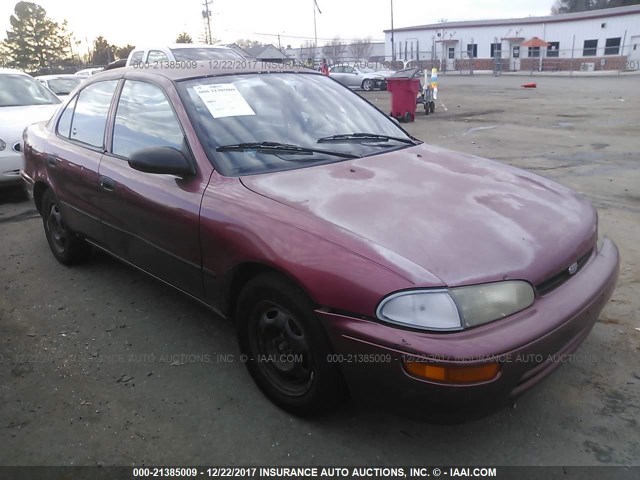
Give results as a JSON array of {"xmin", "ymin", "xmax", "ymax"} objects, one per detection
[{"xmin": 179, "ymin": 73, "xmax": 414, "ymax": 176}]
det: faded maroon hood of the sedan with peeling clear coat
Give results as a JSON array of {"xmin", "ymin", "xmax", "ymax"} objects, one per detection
[{"xmin": 242, "ymin": 144, "xmax": 597, "ymax": 286}]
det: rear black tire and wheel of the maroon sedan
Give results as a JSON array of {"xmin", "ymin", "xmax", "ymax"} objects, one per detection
[{"xmin": 40, "ymin": 190, "xmax": 91, "ymax": 265}]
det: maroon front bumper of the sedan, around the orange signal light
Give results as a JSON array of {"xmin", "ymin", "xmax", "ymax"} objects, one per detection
[{"xmin": 317, "ymin": 238, "xmax": 619, "ymax": 417}]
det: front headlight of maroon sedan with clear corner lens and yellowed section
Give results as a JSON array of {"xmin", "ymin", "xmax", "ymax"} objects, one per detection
[{"xmin": 376, "ymin": 280, "xmax": 535, "ymax": 331}]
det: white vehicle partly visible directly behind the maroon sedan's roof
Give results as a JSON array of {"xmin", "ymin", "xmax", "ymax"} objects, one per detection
[{"xmin": 127, "ymin": 43, "xmax": 248, "ymax": 68}]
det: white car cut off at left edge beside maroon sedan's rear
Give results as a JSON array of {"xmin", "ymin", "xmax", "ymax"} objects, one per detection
[{"xmin": 0, "ymin": 68, "xmax": 61, "ymax": 187}]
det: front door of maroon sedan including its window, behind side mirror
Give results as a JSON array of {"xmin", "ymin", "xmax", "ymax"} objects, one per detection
[{"xmin": 99, "ymin": 80, "xmax": 210, "ymax": 297}]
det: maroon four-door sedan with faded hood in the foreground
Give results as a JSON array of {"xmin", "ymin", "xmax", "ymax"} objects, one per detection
[{"xmin": 23, "ymin": 64, "xmax": 619, "ymax": 416}]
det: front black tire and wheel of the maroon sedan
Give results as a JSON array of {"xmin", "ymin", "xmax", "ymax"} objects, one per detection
[{"xmin": 236, "ymin": 273, "xmax": 345, "ymax": 416}]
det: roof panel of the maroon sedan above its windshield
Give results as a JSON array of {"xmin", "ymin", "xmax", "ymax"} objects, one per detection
[{"xmin": 82, "ymin": 60, "xmax": 321, "ymax": 84}]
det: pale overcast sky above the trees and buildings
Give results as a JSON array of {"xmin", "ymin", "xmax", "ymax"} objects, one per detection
[{"xmin": 0, "ymin": 0, "xmax": 553, "ymax": 53}]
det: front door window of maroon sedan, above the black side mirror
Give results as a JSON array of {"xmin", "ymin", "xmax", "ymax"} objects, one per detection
[{"xmin": 112, "ymin": 80, "xmax": 184, "ymax": 157}]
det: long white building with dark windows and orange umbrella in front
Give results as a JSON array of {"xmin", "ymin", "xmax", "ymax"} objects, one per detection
[{"xmin": 385, "ymin": 5, "xmax": 640, "ymax": 71}]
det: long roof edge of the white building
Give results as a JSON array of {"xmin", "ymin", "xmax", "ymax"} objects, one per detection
[{"xmin": 384, "ymin": 5, "xmax": 640, "ymax": 33}]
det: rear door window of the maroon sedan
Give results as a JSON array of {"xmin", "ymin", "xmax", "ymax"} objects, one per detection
[{"xmin": 69, "ymin": 80, "xmax": 118, "ymax": 148}]
